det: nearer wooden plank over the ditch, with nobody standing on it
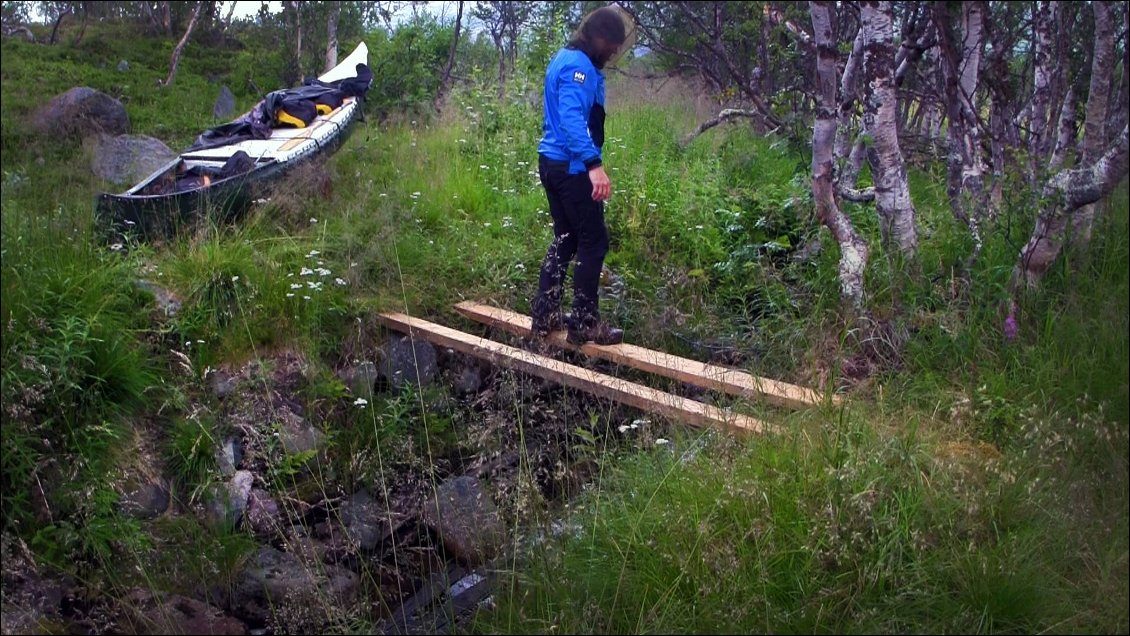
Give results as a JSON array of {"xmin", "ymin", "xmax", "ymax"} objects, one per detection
[{"xmin": 377, "ymin": 313, "xmax": 770, "ymax": 433}]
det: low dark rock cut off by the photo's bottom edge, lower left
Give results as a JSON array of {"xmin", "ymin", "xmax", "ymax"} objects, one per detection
[{"xmin": 119, "ymin": 587, "xmax": 247, "ymax": 635}]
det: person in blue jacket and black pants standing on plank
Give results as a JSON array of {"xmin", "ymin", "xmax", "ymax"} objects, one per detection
[{"xmin": 530, "ymin": 6, "xmax": 631, "ymax": 345}]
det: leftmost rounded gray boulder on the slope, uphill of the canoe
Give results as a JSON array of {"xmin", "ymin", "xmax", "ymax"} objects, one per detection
[{"xmin": 32, "ymin": 86, "xmax": 130, "ymax": 139}]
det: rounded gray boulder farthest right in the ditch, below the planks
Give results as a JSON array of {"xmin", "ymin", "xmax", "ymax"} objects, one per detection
[{"xmin": 423, "ymin": 476, "xmax": 505, "ymax": 567}]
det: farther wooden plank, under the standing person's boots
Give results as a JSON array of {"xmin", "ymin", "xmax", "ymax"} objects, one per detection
[{"xmin": 455, "ymin": 300, "xmax": 841, "ymax": 409}]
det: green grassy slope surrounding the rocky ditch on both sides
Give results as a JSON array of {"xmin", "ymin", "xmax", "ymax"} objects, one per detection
[{"xmin": 2, "ymin": 22, "xmax": 1130, "ymax": 633}]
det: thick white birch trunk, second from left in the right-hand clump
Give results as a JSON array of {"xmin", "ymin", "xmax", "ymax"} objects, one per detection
[{"xmin": 860, "ymin": 1, "xmax": 918, "ymax": 259}]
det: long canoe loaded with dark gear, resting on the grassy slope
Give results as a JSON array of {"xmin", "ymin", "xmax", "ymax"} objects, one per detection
[{"xmin": 95, "ymin": 42, "xmax": 372, "ymax": 242}]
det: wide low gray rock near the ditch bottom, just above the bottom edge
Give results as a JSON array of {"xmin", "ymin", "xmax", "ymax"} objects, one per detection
[{"xmin": 229, "ymin": 546, "xmax": 360, "ymax": 624}]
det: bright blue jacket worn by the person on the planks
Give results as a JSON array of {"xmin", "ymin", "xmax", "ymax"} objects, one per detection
[{"xmin": 538, "ymin": 46, "xmax": 605, "ymax": 174}]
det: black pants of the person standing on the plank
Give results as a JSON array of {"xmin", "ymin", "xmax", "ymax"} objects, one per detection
[{"xmin": 530, "ymin": 155, "xmax": 608, "ymax": 326}]
